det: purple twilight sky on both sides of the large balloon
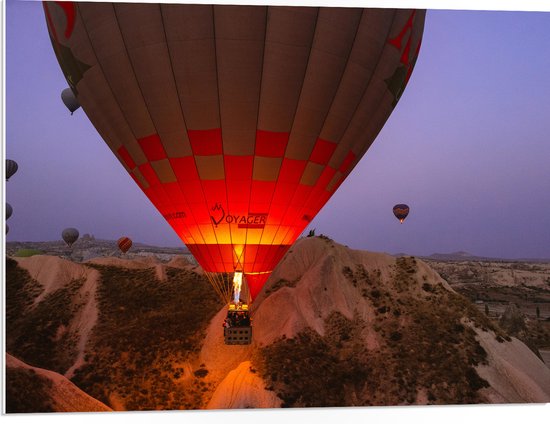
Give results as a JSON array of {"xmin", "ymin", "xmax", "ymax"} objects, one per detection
[{"xmin": 5, "ymin": 0, "xmax": 550, "ymax": 258}]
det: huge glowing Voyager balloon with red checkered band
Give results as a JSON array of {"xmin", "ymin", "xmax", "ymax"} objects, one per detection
[{"xmin": 44, "ymin": 2, "xmax": 425, "ymax": 300}]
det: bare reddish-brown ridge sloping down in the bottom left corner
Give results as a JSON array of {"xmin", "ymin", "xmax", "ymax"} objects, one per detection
[{"xmin": 6, "ymin": 353, "xmax": 112, "ymax": 412}]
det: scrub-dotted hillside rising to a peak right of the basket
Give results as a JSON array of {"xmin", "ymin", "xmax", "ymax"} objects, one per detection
[{"xmin": 208, "ymin": 237, "xmax": 550, "ymax": 407}]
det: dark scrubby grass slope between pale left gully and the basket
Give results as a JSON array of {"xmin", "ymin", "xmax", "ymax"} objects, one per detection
[{"xmin": 73, "ymin": 265, "xmax": 219, "ymax": 410}]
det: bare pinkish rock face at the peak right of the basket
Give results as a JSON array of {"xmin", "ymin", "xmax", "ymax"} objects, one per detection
[{"xmin": 254, "ymin": 238, "xmax": 453, "ymax": 345}]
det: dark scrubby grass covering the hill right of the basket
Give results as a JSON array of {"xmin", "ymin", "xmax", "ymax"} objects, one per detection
[{"xmin": 253, "ymin": 258, "xmax": 501, "ymax": 407}]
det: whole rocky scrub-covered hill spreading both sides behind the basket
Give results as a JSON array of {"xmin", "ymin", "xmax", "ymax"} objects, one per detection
[{"xmin": 6, "ymin": 237, "xmax": 550, "ymax": 410}]
